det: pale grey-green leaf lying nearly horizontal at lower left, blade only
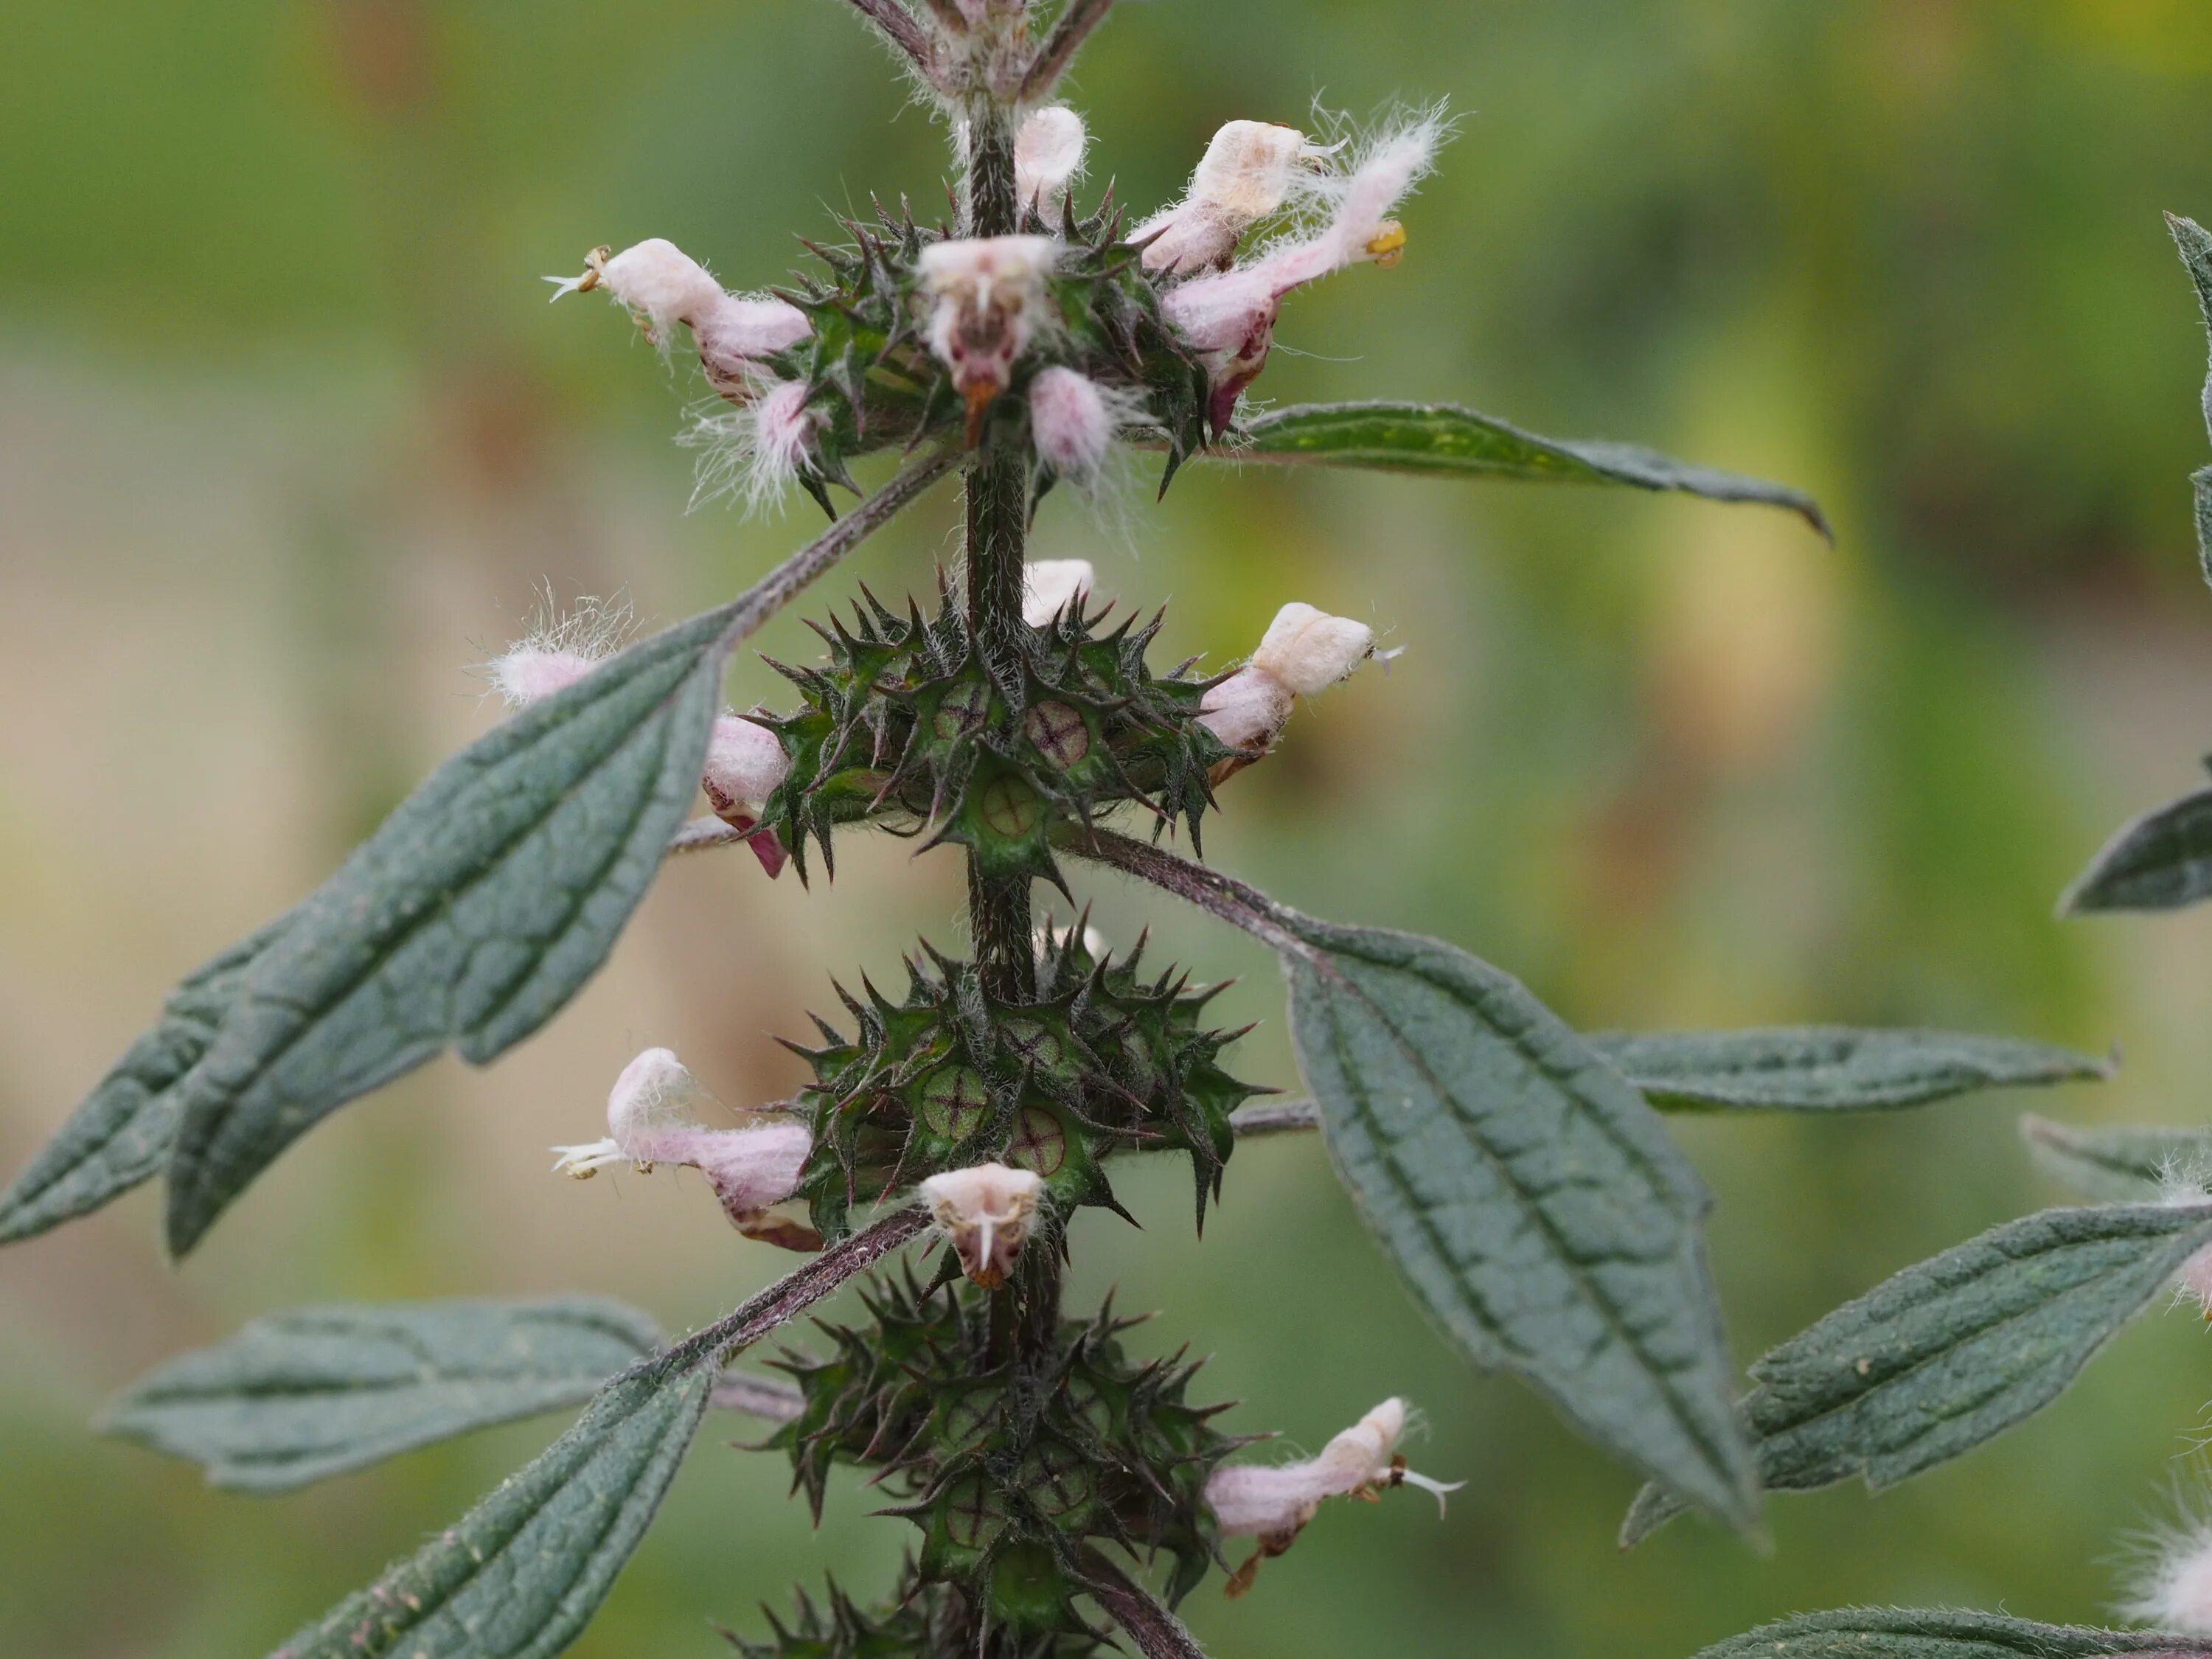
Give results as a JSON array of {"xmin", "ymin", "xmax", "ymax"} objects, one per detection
[{"xmin": 102, "ymin": 1296, "xmax": 659, "ymax": 1493}]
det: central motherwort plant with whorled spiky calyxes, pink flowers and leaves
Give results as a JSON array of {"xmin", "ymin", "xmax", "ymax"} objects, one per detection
[{"xmin": 0, "ymin": 0, "xmax": 2124, "ymax": 1659}]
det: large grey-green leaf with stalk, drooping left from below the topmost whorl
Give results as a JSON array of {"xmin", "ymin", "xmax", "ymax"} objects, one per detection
[{"xmin": 153, "ymin": 453, "xmax": 951, "ymax": 1254}]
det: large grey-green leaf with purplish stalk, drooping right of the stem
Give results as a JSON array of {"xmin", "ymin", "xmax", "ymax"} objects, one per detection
[{"xmin": 1066, "ymin": 834, "xmax": 1759, "ymax": 1526}]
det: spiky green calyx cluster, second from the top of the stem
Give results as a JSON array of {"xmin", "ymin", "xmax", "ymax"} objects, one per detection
[{"xmin": 754, "ymin": 591, "xmax": 1237, "ymax": 891}]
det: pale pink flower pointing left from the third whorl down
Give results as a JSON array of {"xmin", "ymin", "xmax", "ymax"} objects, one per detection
[{"xmin": 553, "ymin": 1048, "xmax": 821, "ymax": 1248}]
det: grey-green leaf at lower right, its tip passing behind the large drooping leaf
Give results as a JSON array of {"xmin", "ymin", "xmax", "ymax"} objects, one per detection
[{"xmin": 1621, "ymin": 1203, "xmax": 2212, "ymax": 1544}]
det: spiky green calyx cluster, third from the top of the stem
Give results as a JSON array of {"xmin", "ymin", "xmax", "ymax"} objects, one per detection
[{"xmin": 790, "ymin": 927, "xmax": 1267, "ymax": 1239}]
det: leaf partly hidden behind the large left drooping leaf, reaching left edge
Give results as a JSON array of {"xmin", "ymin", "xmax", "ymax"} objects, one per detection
[{"xmin": 0, "ymin": 918, "xmax": 290, "ymax": 1243}]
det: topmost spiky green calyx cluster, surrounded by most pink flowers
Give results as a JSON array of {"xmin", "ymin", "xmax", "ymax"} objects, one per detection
[{"xmin": 757, "ymin": 195, "xmax": 1208, "ymax": 511}]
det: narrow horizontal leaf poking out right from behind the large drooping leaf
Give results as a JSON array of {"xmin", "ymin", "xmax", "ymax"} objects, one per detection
[{"xmin": 1590, "ymin": 1026, "xmax": 2110, "ymax": 1113}]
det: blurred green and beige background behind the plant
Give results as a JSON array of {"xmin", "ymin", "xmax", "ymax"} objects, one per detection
[{"xmin": 0, "ymin": 0, "xmax": 2212, "ymax": 1659}]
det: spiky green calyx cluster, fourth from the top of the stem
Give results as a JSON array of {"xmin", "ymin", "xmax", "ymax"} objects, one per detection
[{"xmin": 770, "ymin": 1276, "xmax": 1243, "ymax": 1637}]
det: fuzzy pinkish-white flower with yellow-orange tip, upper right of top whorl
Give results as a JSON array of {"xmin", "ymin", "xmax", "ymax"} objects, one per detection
[{"xmin": 1161, "ymin": 115, "xmax": 1447, "ymax": 434}]
